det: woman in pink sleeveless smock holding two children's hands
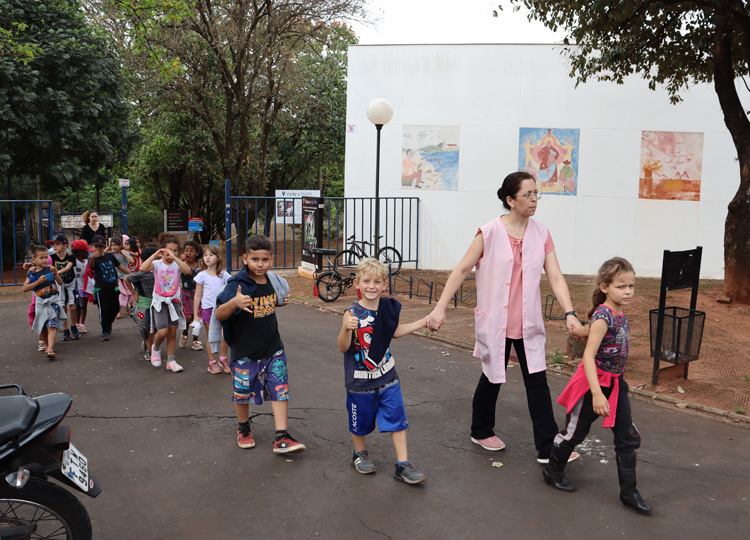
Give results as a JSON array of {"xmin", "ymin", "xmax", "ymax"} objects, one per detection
[{"xmin": 427, "ymin": 172, "xmax": 581, "ymax": 463}]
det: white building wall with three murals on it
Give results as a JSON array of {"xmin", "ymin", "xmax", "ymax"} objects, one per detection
[{"xmin": 346, "ymin": 45, "xmax": 750, "ymax": 279}]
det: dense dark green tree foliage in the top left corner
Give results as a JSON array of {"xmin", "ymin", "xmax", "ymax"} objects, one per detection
[{"xmin": 0, "ymin": 0, "xmax": 132, "ymax": 190}]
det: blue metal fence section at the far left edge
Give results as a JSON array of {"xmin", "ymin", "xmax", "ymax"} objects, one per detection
[{"xmin": 0, "ymin": 200, "xmax": 55, "ymax": 287}]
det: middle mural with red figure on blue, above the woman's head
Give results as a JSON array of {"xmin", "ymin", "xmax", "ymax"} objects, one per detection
[{"xmin": 518, "ymin": 128, "xmax": 581, "ymax": 195}]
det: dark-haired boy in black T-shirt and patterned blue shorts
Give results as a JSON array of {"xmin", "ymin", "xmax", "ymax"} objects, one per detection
[{"xmin": 214, "ymin": 235, "xmax": 305, "ymax": 454}]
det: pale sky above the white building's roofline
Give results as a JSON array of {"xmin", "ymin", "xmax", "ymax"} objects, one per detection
[{"xmin": 352, "ymin": 0, "xmax": 564, "ymax": 45}]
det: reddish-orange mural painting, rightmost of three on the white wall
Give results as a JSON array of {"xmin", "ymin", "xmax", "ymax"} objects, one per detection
[{"xmin": 638, "ymin": 131, "xmax": 703, "ymax": 201}]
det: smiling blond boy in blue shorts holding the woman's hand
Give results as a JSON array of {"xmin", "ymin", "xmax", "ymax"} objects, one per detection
[{"xmin": 337, "ymin": 259, "xmax": 427, "ymax": 484}]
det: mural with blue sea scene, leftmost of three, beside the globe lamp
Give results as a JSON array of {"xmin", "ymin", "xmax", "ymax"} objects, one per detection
[{"xmin": 401, "ymin": 126, "xmax": 459, "ymax": 191}]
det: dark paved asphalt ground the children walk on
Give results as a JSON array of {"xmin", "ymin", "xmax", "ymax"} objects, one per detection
[{"xmin": 0, "ymin": 301, "xmax": 750, "ymax": 540}]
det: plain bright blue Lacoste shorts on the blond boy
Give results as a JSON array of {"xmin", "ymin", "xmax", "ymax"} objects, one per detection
[{"xmin": 346, "ymin": 383, "xmax": 409, "ymax": 435}]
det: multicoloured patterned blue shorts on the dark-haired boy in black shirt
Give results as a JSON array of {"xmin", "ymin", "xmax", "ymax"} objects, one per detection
[{"xmin": 229, "ymin": 349, "xmax": 289, "ymax": 405}]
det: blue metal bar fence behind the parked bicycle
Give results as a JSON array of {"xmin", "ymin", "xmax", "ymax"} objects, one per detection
[{"xmin": 226, "ymin": 196, "xmax": 419, "ymax": 270}]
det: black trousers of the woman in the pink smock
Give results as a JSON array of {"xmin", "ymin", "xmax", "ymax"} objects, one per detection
[{"xmin": 471, "ymin": 338, "xmax": 557, "ymax": 458}]
